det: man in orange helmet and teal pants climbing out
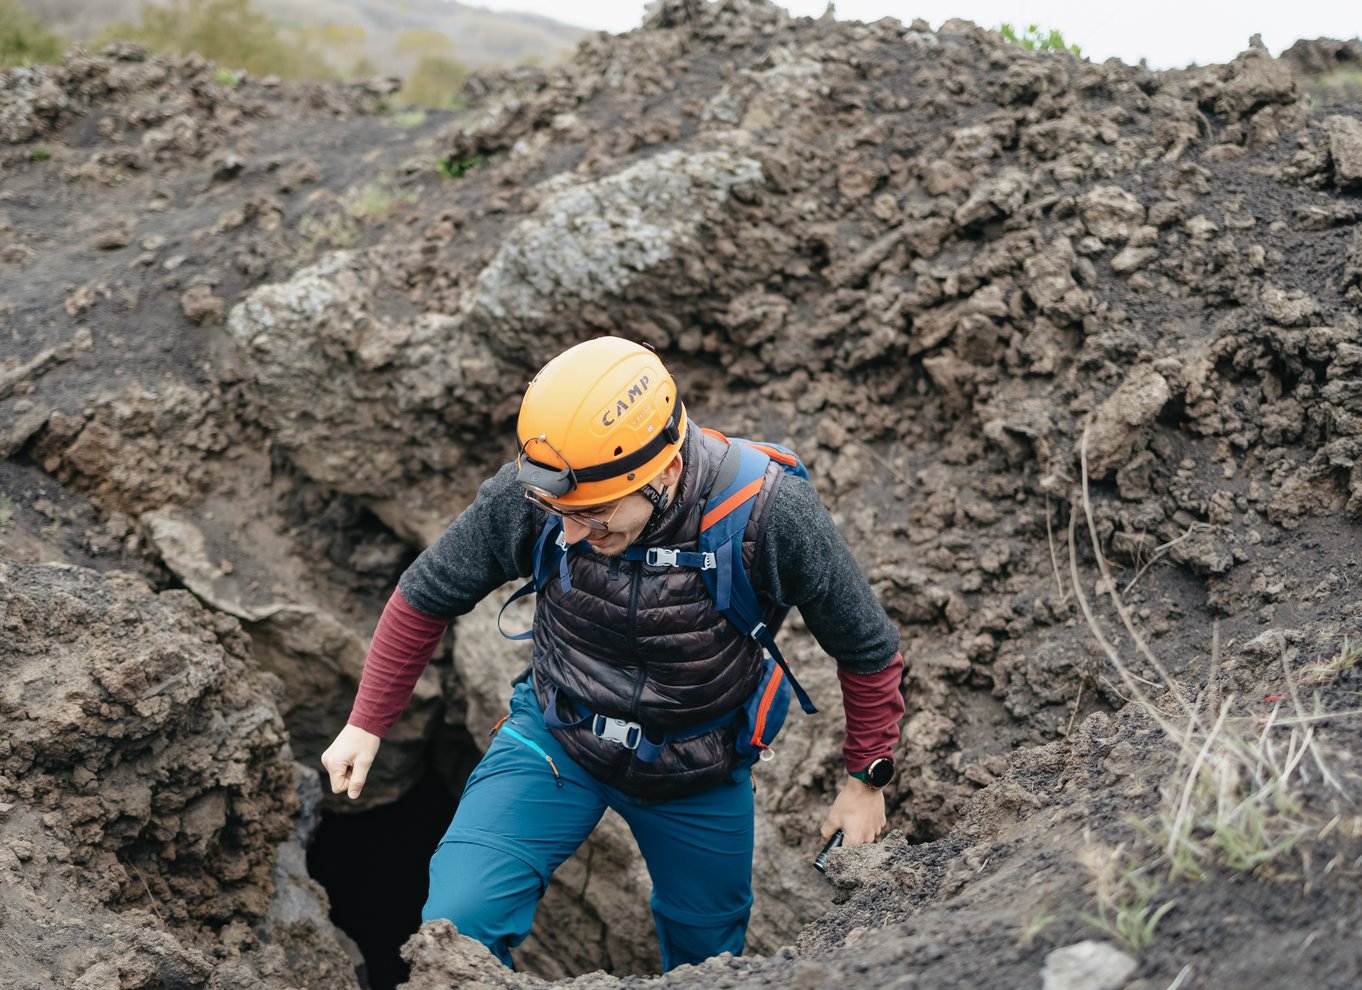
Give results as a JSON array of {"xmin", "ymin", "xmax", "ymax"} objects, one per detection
[{"xmin": 321, "ymin": 338, "xmax": 903, "ymax": 970}]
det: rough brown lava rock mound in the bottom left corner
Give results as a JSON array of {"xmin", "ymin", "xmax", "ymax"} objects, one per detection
[{"xmin": 0, "ymin": 564, "xmax": 354, "ymax": 990}]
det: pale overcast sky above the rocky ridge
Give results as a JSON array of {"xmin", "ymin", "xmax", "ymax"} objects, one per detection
[{"xmin": 464, "ymin": 0, "xmax": 1362, "ymax": 68}]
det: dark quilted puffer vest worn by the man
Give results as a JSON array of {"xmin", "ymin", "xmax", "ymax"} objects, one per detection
[{"xmin": 534, "ymin": 425, "xmax": 783, "ymax": 801}]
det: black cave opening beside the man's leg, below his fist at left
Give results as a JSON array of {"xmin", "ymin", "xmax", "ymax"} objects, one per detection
[{"xmin": 308, "ymin": 769, "xmax": 458, "ymax": 990}]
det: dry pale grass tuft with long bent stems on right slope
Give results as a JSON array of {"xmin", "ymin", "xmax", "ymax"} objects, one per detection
[{"xmin": 1056, "ymin": 432, "xmax": 1362, "ymax": 949}]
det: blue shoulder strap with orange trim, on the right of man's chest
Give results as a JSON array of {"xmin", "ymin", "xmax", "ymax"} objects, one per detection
[{"xmin": 700, "ymin": 440, "xmax": 819, "ymax": 715}]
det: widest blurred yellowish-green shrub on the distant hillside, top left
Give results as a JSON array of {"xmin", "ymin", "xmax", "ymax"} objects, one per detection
[{"xmin": 98, "ymin": 0, "xmax": 336, "ymax": 79}]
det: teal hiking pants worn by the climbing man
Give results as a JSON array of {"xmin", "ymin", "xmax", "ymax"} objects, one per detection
[{"xmin": 421, "ymin": 684, "xmax": 753, "ymax": 970}]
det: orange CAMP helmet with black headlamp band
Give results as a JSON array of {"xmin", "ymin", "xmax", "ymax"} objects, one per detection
[{"xmin": 516, "ymin": 336, "xmax": 686, "ymax": 508}]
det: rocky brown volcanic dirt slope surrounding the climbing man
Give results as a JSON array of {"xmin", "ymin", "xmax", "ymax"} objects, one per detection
[{"xmin": 0, "ymin": 1, "xmax": 1362, "ymax": 989}]
